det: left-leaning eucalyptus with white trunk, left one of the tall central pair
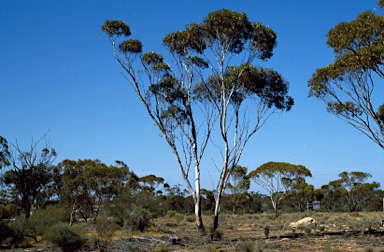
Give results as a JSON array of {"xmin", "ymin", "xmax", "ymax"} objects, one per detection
[{"xmin": 102, "ymin": 20, "xmax": 215, "ymax": 235}]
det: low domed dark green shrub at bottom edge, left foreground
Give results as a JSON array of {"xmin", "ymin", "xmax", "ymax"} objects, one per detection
[{"xmin": 44, "ymin": 223, "xmax": 85, "ymax": 252}]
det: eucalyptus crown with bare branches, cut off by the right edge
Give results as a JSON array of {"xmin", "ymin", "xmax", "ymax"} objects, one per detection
[{"xmin": 308, "ymin": 8, "xmax": 384, "ymax": 149}]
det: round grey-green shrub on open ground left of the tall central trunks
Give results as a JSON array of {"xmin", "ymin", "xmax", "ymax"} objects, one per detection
[{"xmin": 124, "ymin": 207, "xmax": 153, "ymax": 232}]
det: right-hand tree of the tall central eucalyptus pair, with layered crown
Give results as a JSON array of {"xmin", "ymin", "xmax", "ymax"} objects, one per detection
[{"xmin": 190, "ymin": 9, "xmax": 293, "ymax": 230}]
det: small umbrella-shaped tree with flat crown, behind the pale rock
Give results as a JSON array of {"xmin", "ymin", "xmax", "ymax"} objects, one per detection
[{"xmin": 248, "ymin": 162, "xmax": 312, "ymax": 214}]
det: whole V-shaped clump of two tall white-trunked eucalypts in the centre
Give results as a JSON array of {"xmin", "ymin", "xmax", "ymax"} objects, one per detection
[{"xmin": 102, "ymin": 9, "xmax": 293, "ymax": 234}]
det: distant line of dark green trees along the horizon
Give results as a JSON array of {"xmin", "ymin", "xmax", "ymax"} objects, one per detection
[{"xmin": 0, "ymin": 138, "xmax": 384, "ymax": 225}]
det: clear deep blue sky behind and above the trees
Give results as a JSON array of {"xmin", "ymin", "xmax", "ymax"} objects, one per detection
[{"xmin": 0, "ymin": 0, "xmax": 384, "ymax": 191}]
